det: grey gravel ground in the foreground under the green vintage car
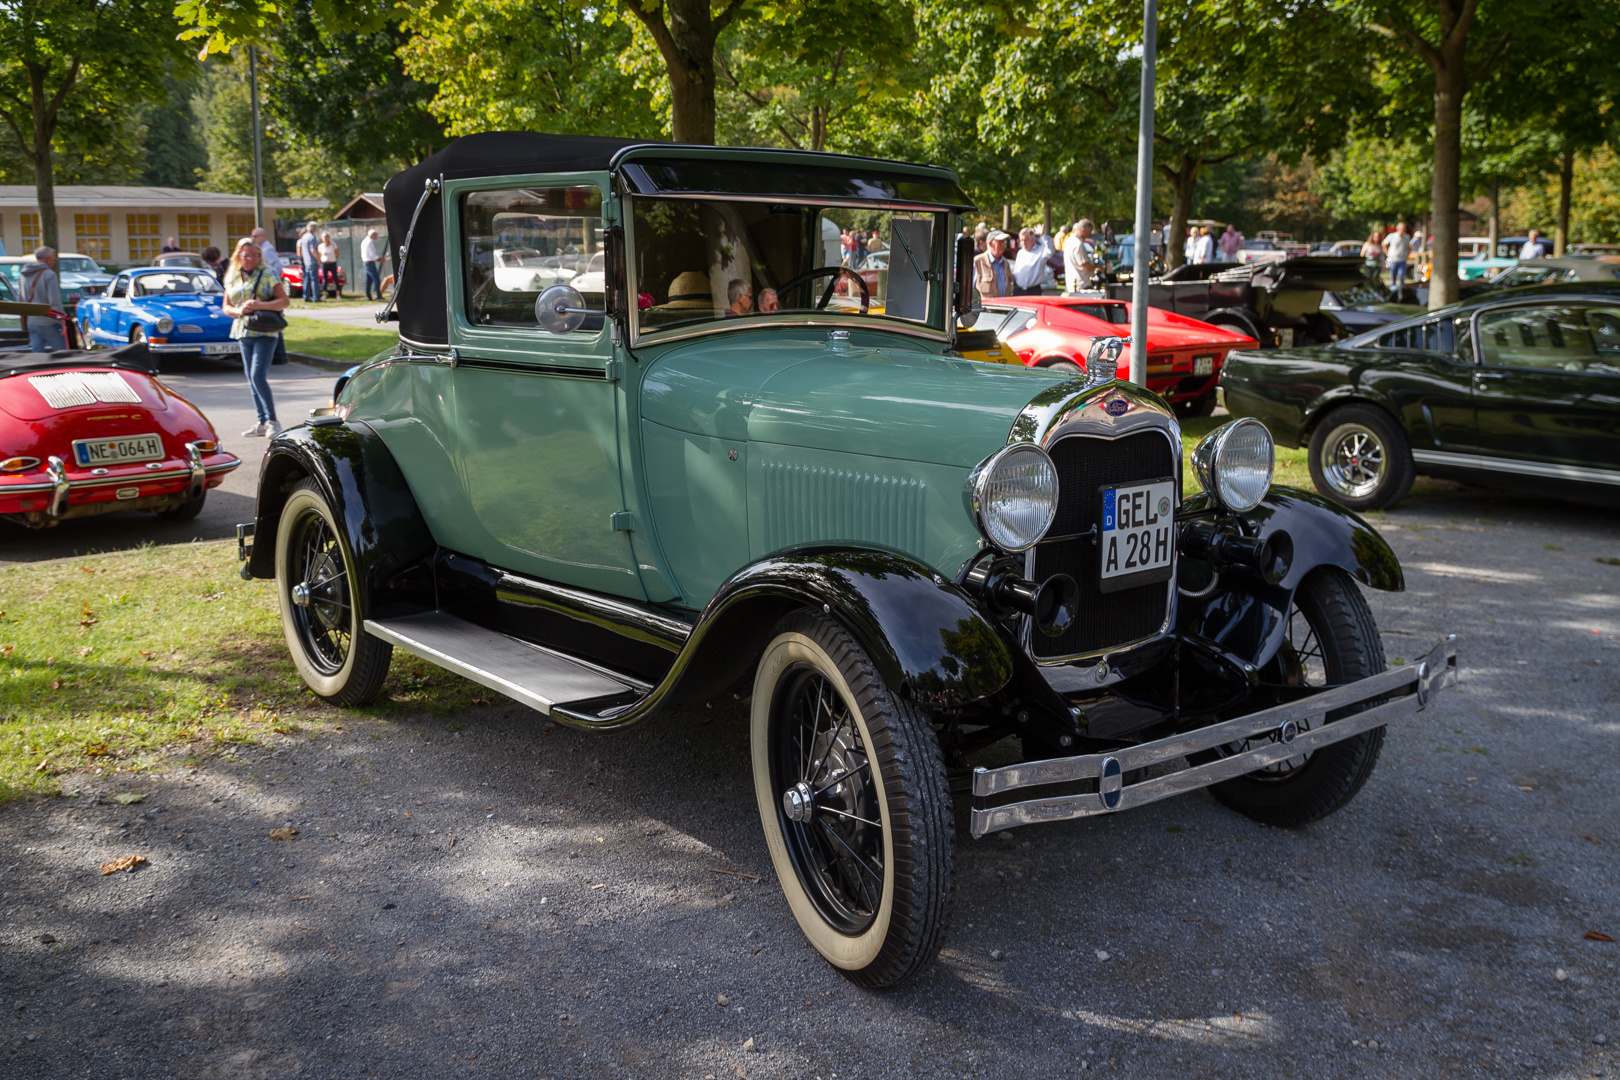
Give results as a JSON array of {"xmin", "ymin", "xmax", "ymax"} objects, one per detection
[{"xmin": 0, "ymin": 489, "xmax": 1620, "ymax": 1080}]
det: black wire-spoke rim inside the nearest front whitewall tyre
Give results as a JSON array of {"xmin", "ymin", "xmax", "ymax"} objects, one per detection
[{"xmin": 771, "ymin": 664, "xmax": 885, "ymax": 934}]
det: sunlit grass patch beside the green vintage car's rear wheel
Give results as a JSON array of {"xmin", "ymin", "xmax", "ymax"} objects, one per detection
[{"xmin": 0, "ymin": 544, "xmax": 479, "ymax": 801}]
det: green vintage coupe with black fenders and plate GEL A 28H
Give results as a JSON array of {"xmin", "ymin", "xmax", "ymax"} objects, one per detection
[{"xmin": 241, "ymin": 133, "xmax": 1455, "ymax": 986}]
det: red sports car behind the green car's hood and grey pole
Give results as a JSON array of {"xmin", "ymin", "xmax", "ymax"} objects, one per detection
[{"xmin": 962, "ymin": 296, "xmax": 1256, "ymax": 416}]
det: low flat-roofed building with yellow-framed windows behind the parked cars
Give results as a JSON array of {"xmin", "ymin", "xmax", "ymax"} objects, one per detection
[{"xmin": 0, "ymin": 185, "xmax": 327, "ymax": 266}]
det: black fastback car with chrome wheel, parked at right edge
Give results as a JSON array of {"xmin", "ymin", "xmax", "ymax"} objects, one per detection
[{"xmin": 1221, "ymin": 283, "xmax": 1620, "ymax": 510}]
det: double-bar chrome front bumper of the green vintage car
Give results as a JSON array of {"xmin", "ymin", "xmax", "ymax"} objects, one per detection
[{"xmin": 970, "ymin": 635, "xmax": 1456, "ymax": 839}]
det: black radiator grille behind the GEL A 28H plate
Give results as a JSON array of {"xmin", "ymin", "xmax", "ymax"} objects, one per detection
[{"xmin": 1029, "ymin": 429, "xmax": 1178, "ymax": 659}]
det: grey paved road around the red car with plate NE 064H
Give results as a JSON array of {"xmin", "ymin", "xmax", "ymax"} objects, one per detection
[{"xmin": 0, "ymin": 358, "xmax": 337, "ymax": 563}]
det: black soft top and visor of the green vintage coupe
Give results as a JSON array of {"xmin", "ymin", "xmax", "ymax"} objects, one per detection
[{"xmin": 382, "ymin": 131, "xmax": 972, "ymax": 347}]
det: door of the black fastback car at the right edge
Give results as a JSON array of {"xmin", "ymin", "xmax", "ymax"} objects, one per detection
[{"xmin": 1473, "ymin": 300, "xmax": 1620, "ymax": 483}]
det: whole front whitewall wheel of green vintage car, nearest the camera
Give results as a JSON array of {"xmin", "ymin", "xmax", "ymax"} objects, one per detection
[{"xmin": 752, "ymin": 610, "xmax": 954, "ymax": 986}]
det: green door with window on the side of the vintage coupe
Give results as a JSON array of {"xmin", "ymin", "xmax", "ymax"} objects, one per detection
[{"xmin": 446, "ymin": 176, "xmax": 648, "ymax": 599}]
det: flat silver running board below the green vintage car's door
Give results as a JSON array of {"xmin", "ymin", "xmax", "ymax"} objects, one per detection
[{"xmin": 366, "ymin": 610, "xmax": 651, "ymax": 716}]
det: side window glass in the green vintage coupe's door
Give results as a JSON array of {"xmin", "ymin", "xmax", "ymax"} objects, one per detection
[{"xmin": 462, "ymin": 186, "xmax": 604, "ymax": 334}]
